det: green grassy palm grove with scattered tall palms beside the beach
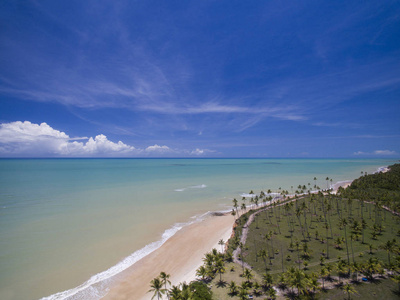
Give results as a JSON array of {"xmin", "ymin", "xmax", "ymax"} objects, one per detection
[{"xmin": 151, "ymin": 164, "xmax": 400, "ymax": 299}]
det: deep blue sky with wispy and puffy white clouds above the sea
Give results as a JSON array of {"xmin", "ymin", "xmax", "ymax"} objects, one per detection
[{"xmin": 0, "ymin": 0, "xmax": 400, "ymax": 159}]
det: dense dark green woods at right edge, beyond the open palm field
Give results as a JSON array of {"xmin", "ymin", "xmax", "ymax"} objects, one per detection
[{"xmin": 342, "ymin": 164, "xmax": 400, "ymax": 213}]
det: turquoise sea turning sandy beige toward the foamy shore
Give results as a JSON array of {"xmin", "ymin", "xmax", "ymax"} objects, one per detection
[{"xmin": 0, "ymin": 159, "xmax": 394, "ymax": 299}]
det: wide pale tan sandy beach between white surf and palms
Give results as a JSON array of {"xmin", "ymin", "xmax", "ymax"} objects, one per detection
[{"xmin": 103, "ymin": 214, "xmax": 234, "ymax": 300}]
